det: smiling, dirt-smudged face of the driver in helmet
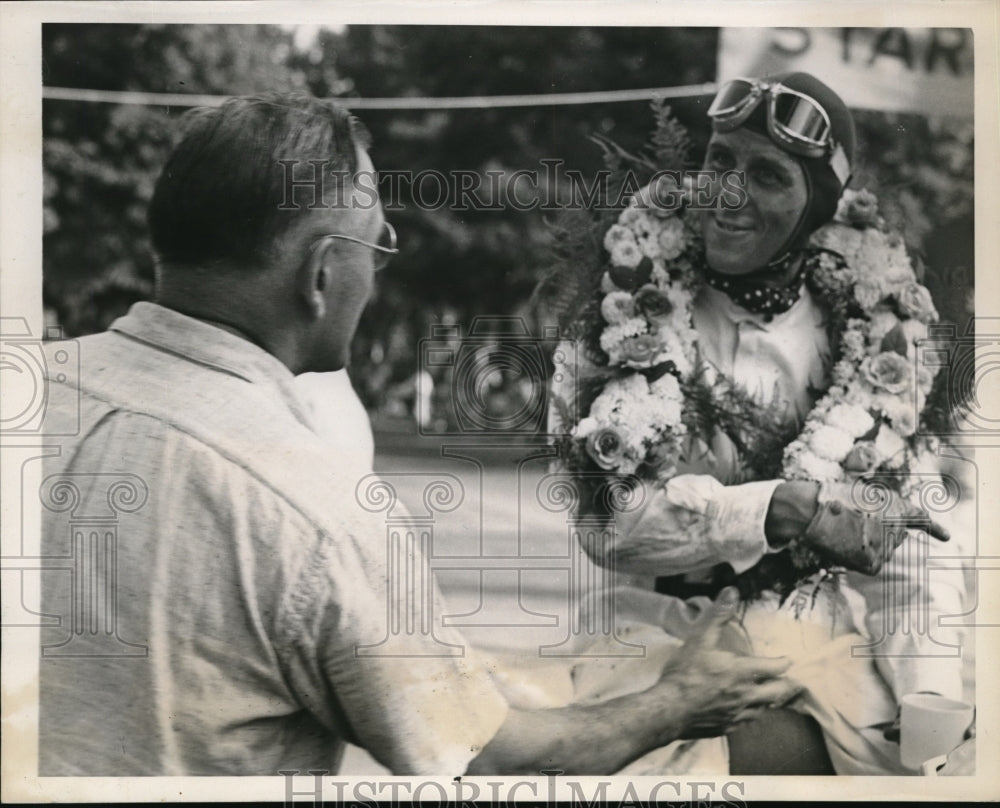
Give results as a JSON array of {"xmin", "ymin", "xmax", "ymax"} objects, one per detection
[{"xmin": 701, "ymin": 129, "xmax": 809, "ymax": 275}]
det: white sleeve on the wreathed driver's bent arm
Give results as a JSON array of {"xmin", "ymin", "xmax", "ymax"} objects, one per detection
[{"xmin": 613, "ymin": 474, "xmax": 781, "ymax": 575}]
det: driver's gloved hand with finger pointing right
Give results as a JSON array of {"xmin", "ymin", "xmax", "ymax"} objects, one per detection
[{"xmin": 765, "ymin": 483, "xmax": 950, "ymax": 575}]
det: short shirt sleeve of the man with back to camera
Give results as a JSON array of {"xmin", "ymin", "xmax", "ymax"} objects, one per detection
[{"xmin": 274, "ymin": 525, "xmax": 508, "ymax": 776}]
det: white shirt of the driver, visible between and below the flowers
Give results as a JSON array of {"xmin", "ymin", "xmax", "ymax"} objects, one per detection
[{"xmin": 616, "ymin": 285, "xmax": 829, "ymax": 575}]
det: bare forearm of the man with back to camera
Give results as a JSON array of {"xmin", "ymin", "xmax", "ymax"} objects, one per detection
[{"xmin": 467, "ymin": 682, "xmax": 689, "ymax": 775}]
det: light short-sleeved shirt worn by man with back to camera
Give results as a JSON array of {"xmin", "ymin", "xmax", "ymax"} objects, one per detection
[{"xmin": 39, "ymin": 303, "xmax": 507, "ymax": 776}]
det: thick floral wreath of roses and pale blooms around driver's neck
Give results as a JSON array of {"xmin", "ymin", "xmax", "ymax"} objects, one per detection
[{"xmin": 553, "ymin": 174, "xmax": 937, "ymax": 598}]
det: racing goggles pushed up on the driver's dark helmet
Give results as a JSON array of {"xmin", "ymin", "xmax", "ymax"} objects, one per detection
[{"xmin": 708, "ymin": 79, "xmax": 851, "ymax": 185}]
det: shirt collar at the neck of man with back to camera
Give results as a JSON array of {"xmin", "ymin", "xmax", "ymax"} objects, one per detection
[{"xmin": 109, "ymin": 302, "xmax": 312, "ymax": 425}]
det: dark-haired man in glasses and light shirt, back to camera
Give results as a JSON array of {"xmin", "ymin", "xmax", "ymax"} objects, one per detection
[{"xmin": 39, "ymin": 95, "xmax": 797, "ymax": 776}]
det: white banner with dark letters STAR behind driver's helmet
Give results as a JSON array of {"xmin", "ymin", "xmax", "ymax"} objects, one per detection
[{"xmin": 717, "ymin": 28, "xmax": 973, "ymax": 117}]
